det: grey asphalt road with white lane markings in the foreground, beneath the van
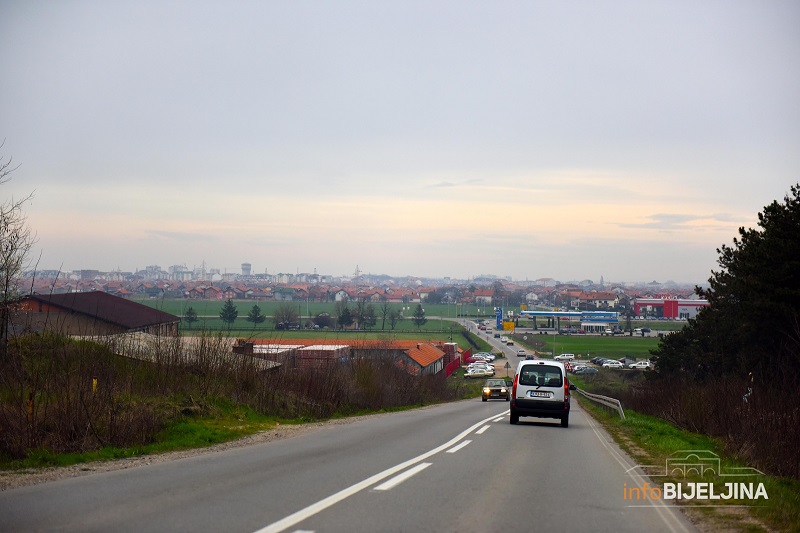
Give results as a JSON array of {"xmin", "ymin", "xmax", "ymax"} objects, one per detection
[{"xmin": 0, "ymin": 398, "xmax": 693, "ymax": 533}]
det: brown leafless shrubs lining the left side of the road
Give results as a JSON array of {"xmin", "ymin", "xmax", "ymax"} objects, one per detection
[{"xmin": 0, "ymin": 334, "xmax": 457, "ymax": 458}]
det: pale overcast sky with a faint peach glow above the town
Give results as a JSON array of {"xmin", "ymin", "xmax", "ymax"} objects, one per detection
[{"xmin": 0, "ymin": 0, "xmax": 800, "ymax": 283}]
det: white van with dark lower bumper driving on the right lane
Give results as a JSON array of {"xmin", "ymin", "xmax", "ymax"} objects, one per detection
[{"xmin": 510, "ymin": 359, "xmax": 575, "ymax": 428}]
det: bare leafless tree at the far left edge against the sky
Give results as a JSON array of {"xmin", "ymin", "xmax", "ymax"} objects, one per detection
[{"xmin": 0, "ymin": 143, "xmax": 36, "ymax": 356}]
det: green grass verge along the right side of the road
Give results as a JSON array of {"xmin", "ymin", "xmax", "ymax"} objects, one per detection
[{"xmin": 570, "ymin": 374, "xmax": 800, "ymax": 532}]
